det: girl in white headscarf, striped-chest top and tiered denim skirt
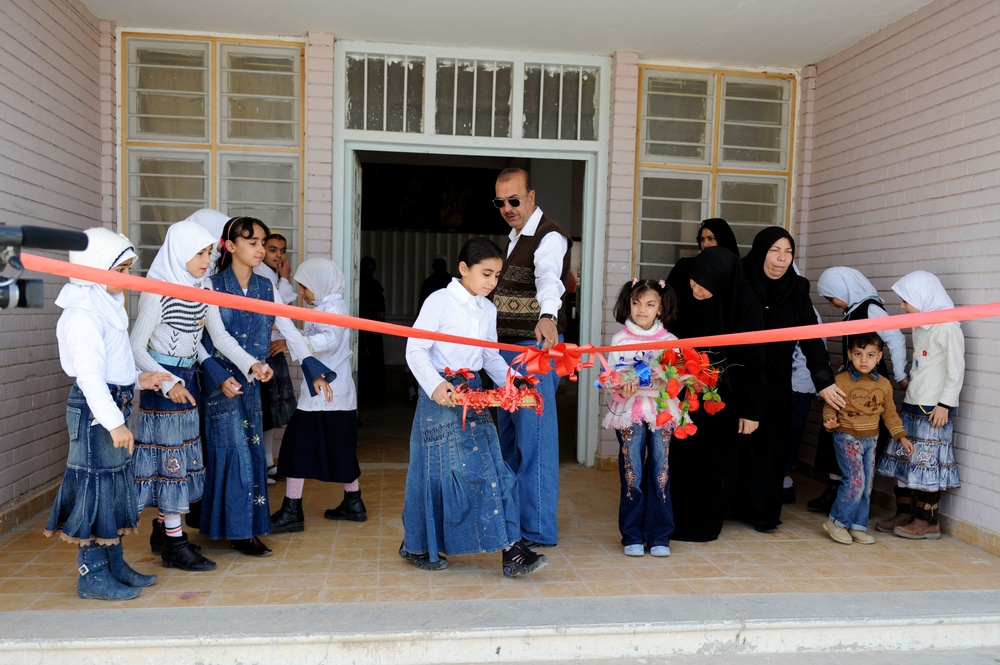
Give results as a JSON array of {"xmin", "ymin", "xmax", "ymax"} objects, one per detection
[{"xmin": 131, "ymin": 219, "xmax": 274, "ymax": 571}]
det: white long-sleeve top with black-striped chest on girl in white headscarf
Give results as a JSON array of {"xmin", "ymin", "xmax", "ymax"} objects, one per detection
[{"xmin": 129, "ymin": 293, "xmax": 257, "ymax": 395}]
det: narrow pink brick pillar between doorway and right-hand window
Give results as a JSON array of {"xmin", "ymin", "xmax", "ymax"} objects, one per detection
[{"xmin": 595, "ymin": 51, "xmax": 639, "ymax": 468}]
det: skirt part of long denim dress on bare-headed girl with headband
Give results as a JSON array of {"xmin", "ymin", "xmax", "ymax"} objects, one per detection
[{"xmin": 201, "ymin": 367, "xmax": 271, "ymax": 540}]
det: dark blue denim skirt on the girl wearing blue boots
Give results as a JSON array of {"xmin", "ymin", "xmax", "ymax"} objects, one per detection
[{"xmin": 45, "ymin": 383, "xmax": 139, "ymax": 545}]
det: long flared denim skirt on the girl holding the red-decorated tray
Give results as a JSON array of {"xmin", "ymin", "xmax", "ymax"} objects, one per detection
[{"xmin": 403, "ymin": 378, "xmax": 521, "ymax": 561}]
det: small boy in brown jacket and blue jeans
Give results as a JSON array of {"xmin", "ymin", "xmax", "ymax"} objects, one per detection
[{"xmin": 823, "ymin": 333, "xmax": 913, "ymax": 545}]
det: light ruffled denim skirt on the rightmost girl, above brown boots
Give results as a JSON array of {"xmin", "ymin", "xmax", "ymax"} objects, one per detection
[{"xmin": 878, "ymin": 403, "xmax": 961, "ymax": 492}]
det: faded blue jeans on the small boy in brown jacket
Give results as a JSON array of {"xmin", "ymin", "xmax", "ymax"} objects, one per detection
[{"xmin": 830, "ymin": 432, "xmax": 878, "ymax": 531}]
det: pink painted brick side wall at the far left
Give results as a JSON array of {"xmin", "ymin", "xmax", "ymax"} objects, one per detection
[{"xmin": 0, "ymin": 0, "xmax": 104, "ymax": 507}]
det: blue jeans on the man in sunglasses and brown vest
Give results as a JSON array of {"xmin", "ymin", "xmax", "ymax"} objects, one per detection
[{"xmin": 499, "ymin": 335, "xmax": 563, "ymax": 545}]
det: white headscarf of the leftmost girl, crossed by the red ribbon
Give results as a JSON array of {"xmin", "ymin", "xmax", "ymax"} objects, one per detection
[{"xmin": 56, "ymin": 227, "xmax": 138, "ymax": 330}]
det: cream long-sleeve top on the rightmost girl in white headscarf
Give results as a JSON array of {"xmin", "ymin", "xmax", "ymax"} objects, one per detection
[{"xmin": 905, "ymin": 322, "xmax": 965, "ymax": 407}]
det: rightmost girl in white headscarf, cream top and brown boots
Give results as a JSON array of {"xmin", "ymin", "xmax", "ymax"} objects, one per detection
[{"xmin": 878, "ymin": 270, "xmax": 965, "ymax": 540}]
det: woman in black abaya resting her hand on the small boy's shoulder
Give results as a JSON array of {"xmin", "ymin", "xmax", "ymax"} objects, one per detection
[{"xmin": 736, "ymin": 226, "xmax": 845, "ymax": 533}]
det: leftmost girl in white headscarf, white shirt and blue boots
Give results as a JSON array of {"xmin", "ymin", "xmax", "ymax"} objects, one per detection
[{"xmin": 45, "ymin": 228, "xmax": 169, "ymax": 600}]
